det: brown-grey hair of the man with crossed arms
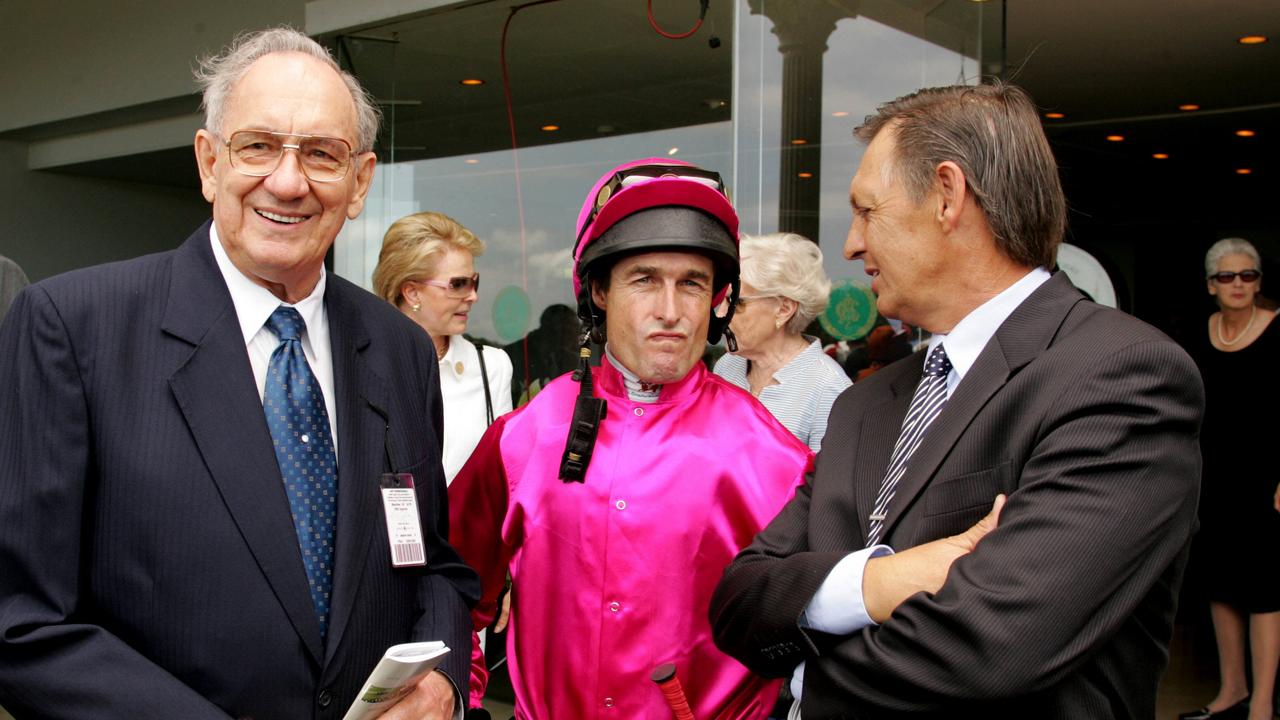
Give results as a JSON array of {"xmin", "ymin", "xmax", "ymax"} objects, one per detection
[{"xmin": 854, "ymin": 82, "xmax": 1066, "ymax": 269}]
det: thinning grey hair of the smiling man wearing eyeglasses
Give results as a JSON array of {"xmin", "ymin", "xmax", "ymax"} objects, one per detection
[{"xmin": 195, "ymin": 26, "xmax": 379, "ymax": 152}]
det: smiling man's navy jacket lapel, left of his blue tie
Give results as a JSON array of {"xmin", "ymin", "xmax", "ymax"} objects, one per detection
[{"xmin": 161, "ymin": 224, "xmax": 321, "ymax": 662}]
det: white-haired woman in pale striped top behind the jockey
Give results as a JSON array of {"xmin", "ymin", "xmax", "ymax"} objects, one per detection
[{"xmin": 716, "ymin": 233, "xmax": 851, "ymax": 452}]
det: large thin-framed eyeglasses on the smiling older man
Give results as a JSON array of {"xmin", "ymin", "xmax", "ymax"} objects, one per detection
[{"xmin": 225, "ymin": 129, "xmax": 351, "ymax": 182}]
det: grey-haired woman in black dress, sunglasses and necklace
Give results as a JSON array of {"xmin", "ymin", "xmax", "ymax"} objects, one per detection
[{"xmin": 1180, "ymin": 238, "xmax": 1280, "ymax": 720}]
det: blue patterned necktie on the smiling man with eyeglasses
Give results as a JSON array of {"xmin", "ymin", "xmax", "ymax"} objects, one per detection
[{"xmin": 262, "ymin": 305, "xmax": 338, "ymax": 639}]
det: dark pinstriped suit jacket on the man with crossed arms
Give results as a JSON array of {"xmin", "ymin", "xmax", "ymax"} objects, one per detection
[{"xmin": 712, "ymin": 274, "xmax": 1203, "ymax": 720}]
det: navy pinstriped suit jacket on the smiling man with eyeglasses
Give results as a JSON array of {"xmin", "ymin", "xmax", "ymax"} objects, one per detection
[{"xmin": 0, "ymin": 224, "xmax": 477, "ymax": 720}]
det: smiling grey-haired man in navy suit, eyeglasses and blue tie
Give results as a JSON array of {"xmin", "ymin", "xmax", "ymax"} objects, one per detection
[{"xmin": 0, "ymin": 28, "xmax": 479, "ymax": 720}]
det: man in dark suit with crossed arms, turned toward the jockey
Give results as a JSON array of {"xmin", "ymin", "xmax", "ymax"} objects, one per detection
[{"xmin": 712, "ymin": 86, "xmax": 1203, "ymax": 720}]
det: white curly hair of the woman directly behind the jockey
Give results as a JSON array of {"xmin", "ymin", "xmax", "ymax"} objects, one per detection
[{"xmin": 739, "ymin": 232, "xmax": 831, "ymax": 334}]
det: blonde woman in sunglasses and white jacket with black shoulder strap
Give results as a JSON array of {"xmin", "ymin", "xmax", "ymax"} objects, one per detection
[{"xmin": 374, "ymin": 213, "xmax": 511, "ymax": 483}]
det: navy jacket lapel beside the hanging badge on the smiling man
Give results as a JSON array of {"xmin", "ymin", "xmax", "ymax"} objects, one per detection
[{"xmin": 325, "ymin": 275, "xmax": 390, "ymax": 659}]
